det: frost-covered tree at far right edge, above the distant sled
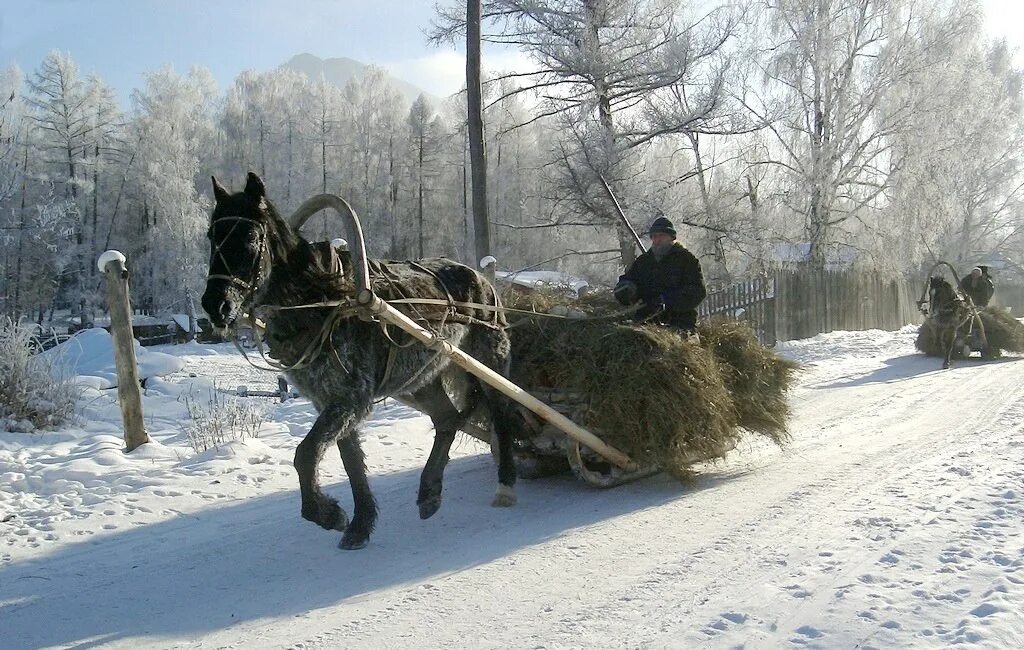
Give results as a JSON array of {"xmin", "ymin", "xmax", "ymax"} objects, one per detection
[{"xmin": 880, "ymin": 25, "xmax": 1024, "ymax": 267}]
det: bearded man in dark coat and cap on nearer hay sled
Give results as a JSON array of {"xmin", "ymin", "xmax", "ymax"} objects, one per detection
[{"xmin": 614, "ymin": 217, "xmax": 708, "ymax": 334}]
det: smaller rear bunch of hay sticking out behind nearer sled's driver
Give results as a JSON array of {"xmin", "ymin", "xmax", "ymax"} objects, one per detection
[{"xmin": 697, "ymin": 318, "xmax": 798, "ymax": 444}]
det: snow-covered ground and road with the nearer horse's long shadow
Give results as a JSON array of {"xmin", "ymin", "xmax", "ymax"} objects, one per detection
[{"xmin": 0, "ymin": 329, "xmax": 1024, "ymax": 649}]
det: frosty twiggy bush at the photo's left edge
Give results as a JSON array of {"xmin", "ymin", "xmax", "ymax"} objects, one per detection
[{"xmin": 0, "ymin": 318, "xmax": 80, "ymax": 432}]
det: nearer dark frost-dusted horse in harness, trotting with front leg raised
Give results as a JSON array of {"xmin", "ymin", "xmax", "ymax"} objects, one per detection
[{"xmin": 203, "ymin": 173, "xmax": 518, "ymax": 549}]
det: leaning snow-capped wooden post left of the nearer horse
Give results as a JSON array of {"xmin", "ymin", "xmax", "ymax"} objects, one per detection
[{"xmin": 96, "ymin": 251, "xmax": 150, "ymax": 451}]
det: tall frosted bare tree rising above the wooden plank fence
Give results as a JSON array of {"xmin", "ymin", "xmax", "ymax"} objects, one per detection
[{"xmin": 746, "ymin": 0, "xmax": 945, "ymax": 266}]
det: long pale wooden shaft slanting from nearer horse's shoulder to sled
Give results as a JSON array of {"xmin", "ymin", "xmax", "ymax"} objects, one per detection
[{"xmin": 358, "ymin": 292, "xmax": 638, "ymax": 472}]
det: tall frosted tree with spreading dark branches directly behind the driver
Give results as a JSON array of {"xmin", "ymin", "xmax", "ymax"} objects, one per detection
[{"xmin": 433, "ymin": 0, "xmax": 740, "ymax": 263}]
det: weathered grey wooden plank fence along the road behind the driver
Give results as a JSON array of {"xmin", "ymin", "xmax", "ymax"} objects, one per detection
[{"xmin": 698, "ymin": 269, "xmax": 924, "ymax": 345}]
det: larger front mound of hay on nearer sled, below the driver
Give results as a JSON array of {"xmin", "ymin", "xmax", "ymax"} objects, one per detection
[{"xmin": 511, "ymin": 320, "xmax": 739, "ymax": 474}]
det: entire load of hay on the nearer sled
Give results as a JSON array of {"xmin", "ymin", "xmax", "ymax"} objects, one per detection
[{"xmin": 506, "ymin": 296, "xmax": 796, "ymax": 476}]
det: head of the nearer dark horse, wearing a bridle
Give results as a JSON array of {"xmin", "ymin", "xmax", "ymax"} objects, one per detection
[{"xmin": 203, "ymin": 172, "xmax": 275, "ymax": 328}]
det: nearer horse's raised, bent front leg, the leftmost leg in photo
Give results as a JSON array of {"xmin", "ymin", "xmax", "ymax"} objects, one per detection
[{"xmin": 295, "ymin": 405, "xmax": 360, "ymax": 530}]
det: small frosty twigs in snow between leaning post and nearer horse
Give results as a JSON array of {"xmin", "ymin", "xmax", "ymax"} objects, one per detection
[{"xmin": 184, "ymin": 390, "xmax": 268, "ymax": 453}]
